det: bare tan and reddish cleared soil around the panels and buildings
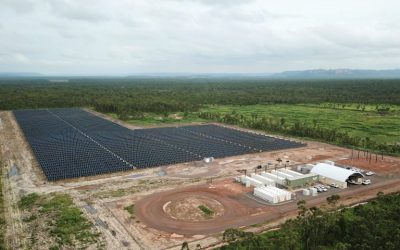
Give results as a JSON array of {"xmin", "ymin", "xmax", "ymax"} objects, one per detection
[{"xmin": 0, "ymin": 111, "xmax": 400, "ymax": 249}]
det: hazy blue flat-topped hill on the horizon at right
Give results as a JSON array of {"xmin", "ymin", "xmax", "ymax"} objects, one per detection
[{"xmin": 270, "ymin": 69, "xmax": 400, "ymax": 79}]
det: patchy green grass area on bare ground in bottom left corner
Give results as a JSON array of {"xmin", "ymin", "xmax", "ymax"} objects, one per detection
[{"xmin": 18, "ymin": 193, "xmax": 99, "ymax": 249}]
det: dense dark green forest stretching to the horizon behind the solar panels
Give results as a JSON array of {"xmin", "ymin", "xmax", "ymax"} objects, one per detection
[{"xmin": 0, "ymin": 77, "xmax": 400, "ymax": 111}]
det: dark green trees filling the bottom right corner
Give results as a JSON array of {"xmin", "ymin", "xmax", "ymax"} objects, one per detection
[{"xmin": 220, "ymin": 193, "xmax": 400, "ymax": 250}]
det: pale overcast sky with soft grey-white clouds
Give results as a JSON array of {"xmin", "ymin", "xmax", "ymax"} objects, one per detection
[{"xmin": 0, "ymin": 0, "xmax": 400, "ymax": 75}]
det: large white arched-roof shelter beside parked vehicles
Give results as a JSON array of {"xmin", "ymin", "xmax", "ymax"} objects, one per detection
[{"xmin": 311, "ymin": 163, "xmax": 364, "ymax": 188}]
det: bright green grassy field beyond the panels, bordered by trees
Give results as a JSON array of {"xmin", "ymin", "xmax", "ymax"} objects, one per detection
[{"xmin": 200, "ymin": 104, "xmax": 400, "ymax": 143}]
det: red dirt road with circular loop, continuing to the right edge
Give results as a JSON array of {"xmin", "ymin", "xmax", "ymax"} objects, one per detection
[{"xmin": 135, "ymin": 179, "xmax": 400, "ymax": 237}]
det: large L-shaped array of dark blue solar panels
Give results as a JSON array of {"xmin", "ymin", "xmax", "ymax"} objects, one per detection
[{"xmin": 14, "ymin": 109, "xmax": 304, "ymax": 181}]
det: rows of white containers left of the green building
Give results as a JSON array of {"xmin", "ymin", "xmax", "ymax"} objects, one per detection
[{"xmin": 236, "ymin": 172, "xmax": 292, "ymax": 204}]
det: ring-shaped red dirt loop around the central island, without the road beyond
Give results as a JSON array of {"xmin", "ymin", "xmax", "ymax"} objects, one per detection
[{"xmin": 136, "ymin": 185, "xmax": 270, "ymax": 236}]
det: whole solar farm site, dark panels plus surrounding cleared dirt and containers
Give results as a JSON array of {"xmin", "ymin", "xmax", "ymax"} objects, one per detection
[{"xmin": 0, "ymin": 108, "xmax": 400, "ymax": 249}]
